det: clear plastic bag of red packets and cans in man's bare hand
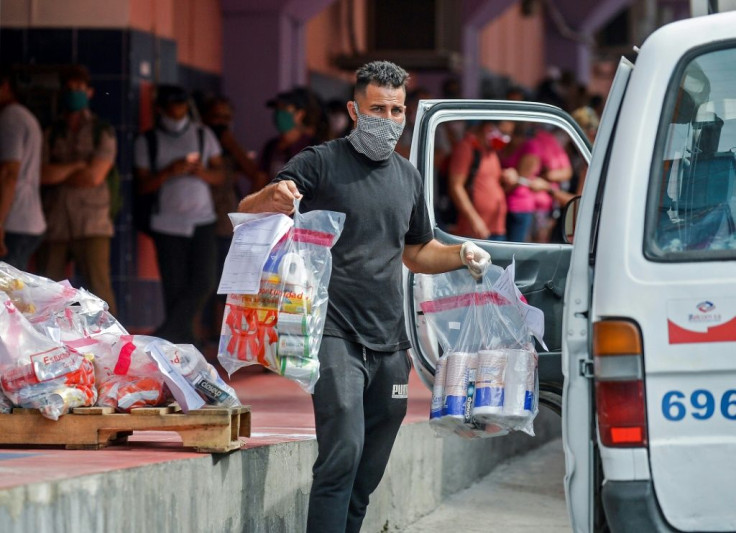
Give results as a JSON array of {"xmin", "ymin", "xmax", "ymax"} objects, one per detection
[{"xmin": 217, "ymin": 202, "xmax": 345, "ymax": 393}]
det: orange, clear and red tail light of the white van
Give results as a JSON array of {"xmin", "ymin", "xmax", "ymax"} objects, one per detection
[{"xmin": 593, "ymin": 320, "xmax": 647, "ymax": 448}]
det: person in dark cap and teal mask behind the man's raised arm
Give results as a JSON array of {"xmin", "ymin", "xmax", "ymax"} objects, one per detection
[{"xmin": 259, "ymin": 89, "xmax": 315, "ymax": 179}]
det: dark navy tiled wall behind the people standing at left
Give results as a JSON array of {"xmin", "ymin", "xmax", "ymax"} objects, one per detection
[{"xmin": 0, "ymin": 28, "xmax": 220, "ymax": 332}]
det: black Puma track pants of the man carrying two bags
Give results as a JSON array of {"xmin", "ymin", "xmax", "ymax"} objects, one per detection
[{"xmin": 307, "ymin": 336, "xmax": 411, "ymax": 533}]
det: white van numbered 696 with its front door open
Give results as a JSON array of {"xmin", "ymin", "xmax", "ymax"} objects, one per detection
[{"xmin": 406, "ymin": 9, "xmax": 736, "ymax": 532}]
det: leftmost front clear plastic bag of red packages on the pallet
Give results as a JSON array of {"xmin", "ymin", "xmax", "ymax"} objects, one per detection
[{"xmin": 0, "ymin": 291, "xmax": 97, "ymax": 420}]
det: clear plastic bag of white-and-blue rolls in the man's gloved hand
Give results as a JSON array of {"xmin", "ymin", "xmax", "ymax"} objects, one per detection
[{"xmin": 418, "ymin": 263, "xmax": 544, "ymax": 437}]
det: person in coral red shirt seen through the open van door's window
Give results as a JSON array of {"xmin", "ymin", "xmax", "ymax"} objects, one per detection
[{"xmin": 449, "ymin": 121, "xmax": 506, "ymax": 241}]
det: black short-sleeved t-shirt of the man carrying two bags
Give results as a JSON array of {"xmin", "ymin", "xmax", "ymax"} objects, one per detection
[{"xmin": 274, "ymin": 138, "xmax": 433, "ymax": 352}]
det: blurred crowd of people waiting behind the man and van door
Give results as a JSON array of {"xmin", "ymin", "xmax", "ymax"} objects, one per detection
[{"xmin": 0, "ymin": 61, "xmax": 603, "ymax": 345}]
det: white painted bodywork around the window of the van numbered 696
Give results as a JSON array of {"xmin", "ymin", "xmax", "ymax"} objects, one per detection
[{"xmin": 591, "ymin": 13, "xmax": 736, "ymax": 531}]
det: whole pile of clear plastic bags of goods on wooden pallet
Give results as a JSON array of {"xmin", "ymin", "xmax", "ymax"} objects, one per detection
[{"xmin": 0, "ymin": 262, "xmax": 240, "ymax": 420}]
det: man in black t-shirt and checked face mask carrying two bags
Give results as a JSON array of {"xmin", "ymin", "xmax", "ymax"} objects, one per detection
[{"xmin": 239, "ymin": 61, "xmax": 490, "ymax": 533}]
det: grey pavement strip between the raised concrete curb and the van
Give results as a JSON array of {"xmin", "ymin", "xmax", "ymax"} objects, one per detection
[{"xmin": 403, "ymin": 439, "xmax": 572, "ymax": 533}]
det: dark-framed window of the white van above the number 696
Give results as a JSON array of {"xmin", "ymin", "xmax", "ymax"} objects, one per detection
[{"xmin": 645, "ymin": 48, "xmax": 736, "ymax": 261}]
